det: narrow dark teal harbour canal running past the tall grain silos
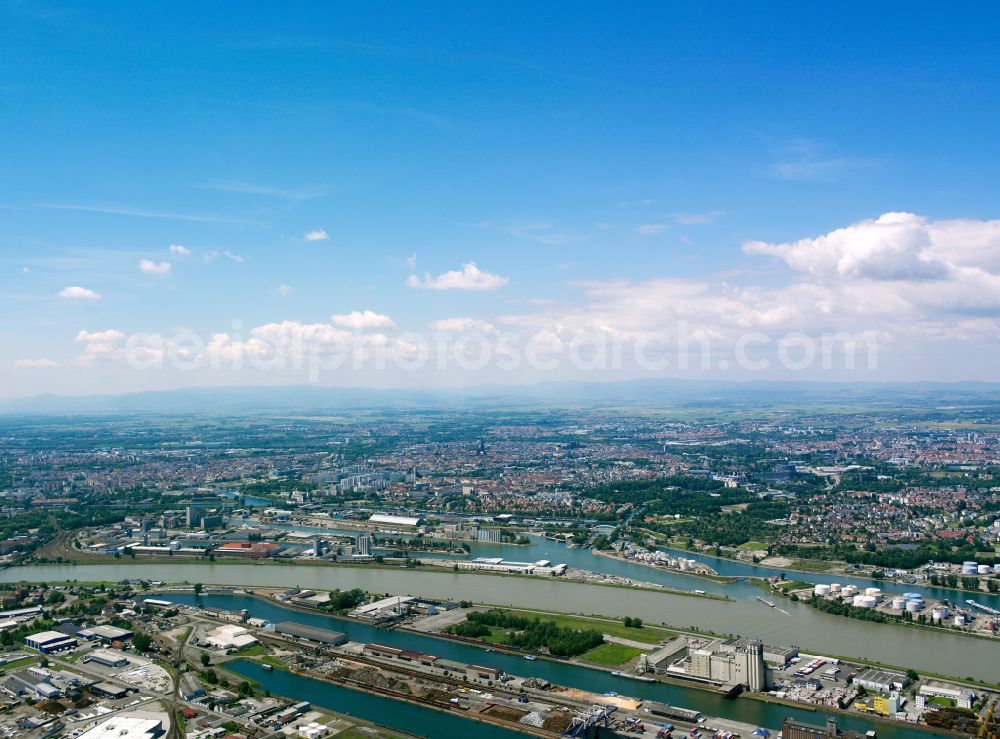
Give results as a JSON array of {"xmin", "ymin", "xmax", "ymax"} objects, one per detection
[{"xmin": 176, "ymin": 593, "xmax": 929, "ymax": 739}]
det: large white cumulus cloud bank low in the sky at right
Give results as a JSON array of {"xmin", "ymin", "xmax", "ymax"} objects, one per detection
[{"xmin": 499, "ymin": 213, "xmax": 1000, "ymax": 356}]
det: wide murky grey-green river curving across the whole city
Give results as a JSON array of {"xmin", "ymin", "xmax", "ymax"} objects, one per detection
[{"xmin": 0, "ymin": 568, "xmax": 1000, "ymax": 682}]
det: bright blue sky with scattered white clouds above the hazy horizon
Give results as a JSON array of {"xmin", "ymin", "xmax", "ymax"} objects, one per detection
[{"xmin": 0, "ymin": 2, "xmax": 1000, "ymax": 395}]
